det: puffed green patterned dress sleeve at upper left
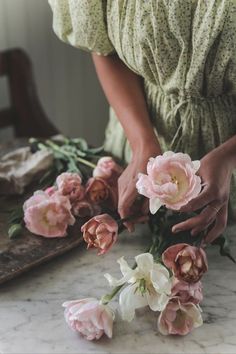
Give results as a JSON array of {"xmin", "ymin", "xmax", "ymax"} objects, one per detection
[{"xmin": 48, "ymin": 0, "xmax": 115, "ymax": 55}]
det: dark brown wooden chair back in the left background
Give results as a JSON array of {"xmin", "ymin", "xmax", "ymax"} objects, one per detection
[{"xmin": 0, "ymin": 49, "xmax": 58, "ymax": 138}]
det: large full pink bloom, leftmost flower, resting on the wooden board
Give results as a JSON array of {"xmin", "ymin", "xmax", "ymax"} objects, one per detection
[{"xmin": 23, "ymin": 191, "xmax": 75, "ymax": 237}]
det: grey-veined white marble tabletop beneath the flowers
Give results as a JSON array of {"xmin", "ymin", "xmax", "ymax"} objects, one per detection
[{"xmin": 0, "ymin": 227, "xmax": 236, "ymax": 354}]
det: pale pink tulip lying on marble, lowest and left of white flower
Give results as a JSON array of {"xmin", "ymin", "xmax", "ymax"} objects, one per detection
[{"xmin": 62, "ymin": 298, "xmax": 115, "ymax": 340}]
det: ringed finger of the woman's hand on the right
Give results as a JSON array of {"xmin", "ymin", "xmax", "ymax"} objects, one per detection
[{"xmin": 172, "ymin": 206, "xmax": 217, "ymax": 233}]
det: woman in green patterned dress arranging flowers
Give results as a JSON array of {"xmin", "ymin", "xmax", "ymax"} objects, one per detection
[{"xmin": 49, "ymin": 0, "xmax": 236, "ymax": 242}]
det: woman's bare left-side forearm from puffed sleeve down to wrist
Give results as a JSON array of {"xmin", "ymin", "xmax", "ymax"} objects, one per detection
[{"xmin": 92, "ymin": 54, "xmax": 157, "ymax": 152}]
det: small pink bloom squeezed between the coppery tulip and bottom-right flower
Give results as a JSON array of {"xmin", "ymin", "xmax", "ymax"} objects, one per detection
[{"xmin": 171, "ymin": 277, "xmax": 203, "ymax": 305}]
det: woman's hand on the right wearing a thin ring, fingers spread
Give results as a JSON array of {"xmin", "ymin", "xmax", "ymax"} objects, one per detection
[{"xmin": 172, "ymin": 146, "xmax": 234, "ymax": 245}]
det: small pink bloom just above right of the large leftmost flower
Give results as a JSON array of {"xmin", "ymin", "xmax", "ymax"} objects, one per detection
[{"xmin": 56, "ymin": 172, "xmax": 84, "ymax": 203}]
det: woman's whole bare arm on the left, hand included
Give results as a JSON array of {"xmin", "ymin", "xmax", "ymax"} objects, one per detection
[{"xmin": 92, "ymin": 54, "xmax": 161, "ymax": 230}]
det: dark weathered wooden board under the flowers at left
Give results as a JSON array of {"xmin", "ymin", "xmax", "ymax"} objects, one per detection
[{"xmin": 0, "ymin": 143, "xmax": 85, "ymax": 284}]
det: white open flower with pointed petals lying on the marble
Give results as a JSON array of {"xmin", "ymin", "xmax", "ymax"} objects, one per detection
[{"xmin": 105, "ymin": 253, "xmax": 171, "ymax": 321}]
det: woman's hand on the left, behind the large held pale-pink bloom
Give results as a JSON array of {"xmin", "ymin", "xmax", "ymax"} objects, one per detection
[{"xmin": 118, "ymin": 143, "xmax": 161, "ymax": 232}]
